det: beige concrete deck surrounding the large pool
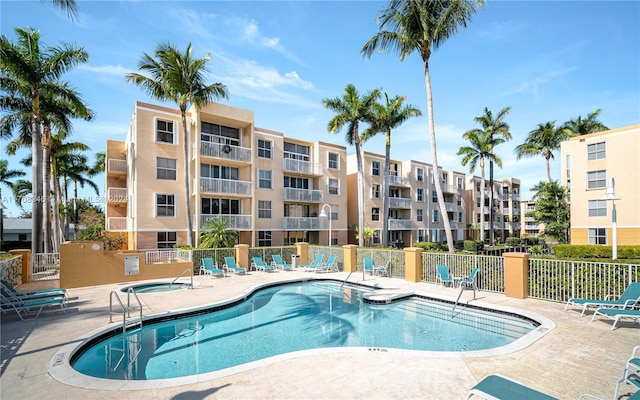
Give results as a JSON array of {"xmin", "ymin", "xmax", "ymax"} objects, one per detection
[{"xmin": 0, "ymin": 271, "xmax": 640, "ymax": 400}]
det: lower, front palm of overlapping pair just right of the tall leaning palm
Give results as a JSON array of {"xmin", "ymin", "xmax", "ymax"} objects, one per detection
[{"xmin": 457, "ymin": 129, "xmax": 504, "ymax": 241}]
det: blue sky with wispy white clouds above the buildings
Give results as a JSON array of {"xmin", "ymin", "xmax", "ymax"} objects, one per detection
[{"xmin": 0, "ymin": 0, "xmax": 640, "ymax": 217}]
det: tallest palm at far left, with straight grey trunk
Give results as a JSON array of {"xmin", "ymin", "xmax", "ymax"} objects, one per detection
[{"xmin": 0, "ymin": 28, "xmax": 89, "ymax": 253}]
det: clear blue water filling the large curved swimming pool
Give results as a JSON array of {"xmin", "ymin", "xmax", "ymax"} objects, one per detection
[{"xmin": 72, "ymin": 281, "xmax": 537, "ymax": 380}]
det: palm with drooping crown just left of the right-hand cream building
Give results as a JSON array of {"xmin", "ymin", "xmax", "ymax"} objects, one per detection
[{"xmin": 515, "ymin": 121, "xmax": 569, "ymax": 182}]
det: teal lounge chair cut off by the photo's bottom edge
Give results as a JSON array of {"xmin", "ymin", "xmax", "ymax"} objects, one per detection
[{"xmin": 467, "ymin": 374, "xmax": 558, "ymax": 400}]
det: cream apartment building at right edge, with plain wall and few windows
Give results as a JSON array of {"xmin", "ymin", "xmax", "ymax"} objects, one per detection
[{"xmin": 560, "ymin": 124, "xmax": 640, "ymax": 246}]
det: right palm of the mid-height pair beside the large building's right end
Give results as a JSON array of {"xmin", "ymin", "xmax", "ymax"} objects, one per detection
[{"xmin": 362, "ymin": 93, "xmax": 422, "ymax": 247}]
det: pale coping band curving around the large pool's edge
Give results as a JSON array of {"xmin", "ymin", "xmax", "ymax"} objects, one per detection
[{"xmin": 48, "ymin": 276, "xmax": 556, "ymax": 391}]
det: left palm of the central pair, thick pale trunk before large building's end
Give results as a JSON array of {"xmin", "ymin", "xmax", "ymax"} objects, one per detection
[{"xmin": 322, "ymin": 83, "xmax": 380, "ymax": 247}]
